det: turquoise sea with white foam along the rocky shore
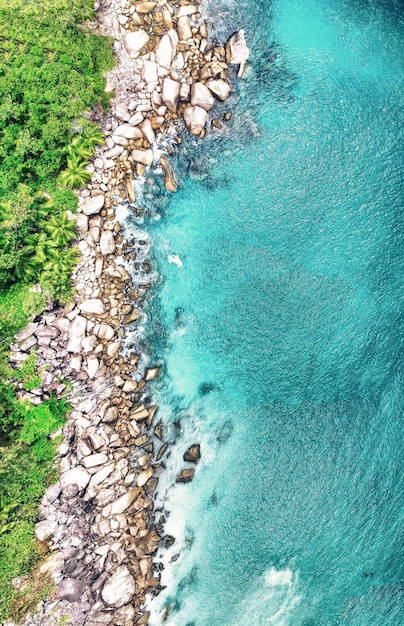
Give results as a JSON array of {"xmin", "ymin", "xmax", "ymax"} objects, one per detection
[{"xmin": 145, "ymin": 0, "xmax": 404, "ymax": 626}]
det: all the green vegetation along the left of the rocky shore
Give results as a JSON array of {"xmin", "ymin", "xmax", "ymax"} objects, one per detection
[{"xmin": 0, "ymin": 0, "xmax": 113, "ymax": 621}]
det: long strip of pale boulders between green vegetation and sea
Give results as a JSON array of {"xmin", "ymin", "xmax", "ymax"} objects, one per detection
[{"xmin": 4, "ymin": 0, "xmax": 248, "ymax": 626}]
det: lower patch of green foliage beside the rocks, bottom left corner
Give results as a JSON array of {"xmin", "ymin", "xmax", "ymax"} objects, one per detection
[{"xmin": 0, "ymin": 398, "xmax": 69, "ymax": 620}]
